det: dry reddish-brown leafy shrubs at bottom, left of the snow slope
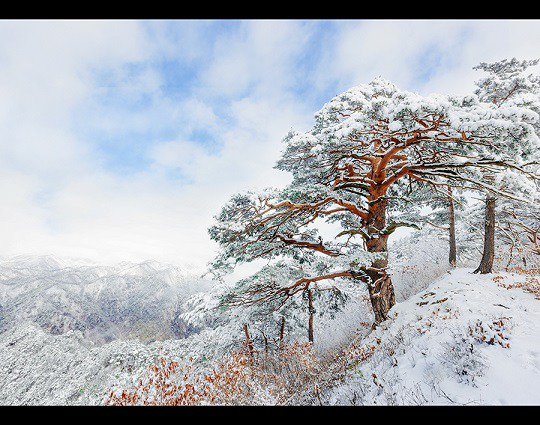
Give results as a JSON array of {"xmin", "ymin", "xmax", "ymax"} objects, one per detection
[{"xmin": 105, "ymin": 343, "xmax": 324, "ymax": 406}]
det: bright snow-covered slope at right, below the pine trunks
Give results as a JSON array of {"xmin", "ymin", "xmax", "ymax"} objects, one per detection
[{"xmin": 326, "ymin": 269, "xmax": 540, "ymax": 405}]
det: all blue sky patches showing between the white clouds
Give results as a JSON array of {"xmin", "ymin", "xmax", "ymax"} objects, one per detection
[{"xmin": 66, "ymin": 20, "xmax": 480, "ymax": 178}]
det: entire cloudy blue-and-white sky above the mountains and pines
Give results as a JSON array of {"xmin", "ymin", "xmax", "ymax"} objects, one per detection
[{"xmin": 0, "ymin": 21, "xmax": 540, "ymax": 266}]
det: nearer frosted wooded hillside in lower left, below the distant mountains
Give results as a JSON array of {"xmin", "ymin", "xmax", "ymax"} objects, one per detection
[{"xmin": 0, "ymin": 323, "xmax": 197, "ymax": 405}]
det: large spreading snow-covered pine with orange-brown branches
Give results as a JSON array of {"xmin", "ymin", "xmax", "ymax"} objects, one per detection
[{"xmin": 209, "ymin": 78, "xmax": 538, "ymax": 324}]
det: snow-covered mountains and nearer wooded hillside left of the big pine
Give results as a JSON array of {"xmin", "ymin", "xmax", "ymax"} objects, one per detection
[{"xmin": 0, "ymin": 256, "xmax": 215, "ymax": 404}]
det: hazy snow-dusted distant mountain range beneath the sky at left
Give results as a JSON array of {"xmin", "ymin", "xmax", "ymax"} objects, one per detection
[{"xmin": 0, "ymin": 256, "xmax": 208, "ymax": 343}]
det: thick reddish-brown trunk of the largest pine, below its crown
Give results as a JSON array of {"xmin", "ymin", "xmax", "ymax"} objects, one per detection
[{"xmin": 366, "ymin": 194, "xmax": 396, "ymax": 326}]
